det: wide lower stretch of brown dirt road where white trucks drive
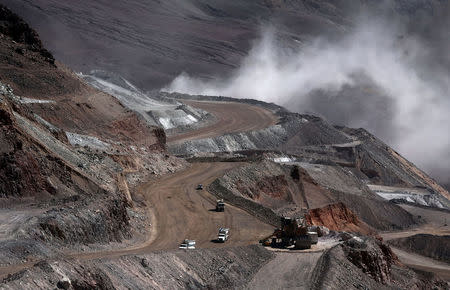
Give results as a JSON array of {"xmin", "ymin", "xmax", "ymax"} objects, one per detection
[{"xmin": 71, "ymin": 162, "xmax": 274, "ymax": 260}]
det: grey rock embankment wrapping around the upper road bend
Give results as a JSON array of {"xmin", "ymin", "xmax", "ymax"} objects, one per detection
[{"xmin": 165, "ymin": 93, "xmax": 353, "ymax": 156}]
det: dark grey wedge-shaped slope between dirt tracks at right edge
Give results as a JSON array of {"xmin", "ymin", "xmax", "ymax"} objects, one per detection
[{"xmin": 389, "ymin": 234, "xmax": 450, "ymax": 262}]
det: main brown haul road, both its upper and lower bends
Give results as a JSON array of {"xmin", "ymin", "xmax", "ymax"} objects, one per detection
[{"xmin": 0, "ymin": 101, "xmax": 278, "ymax": 277}]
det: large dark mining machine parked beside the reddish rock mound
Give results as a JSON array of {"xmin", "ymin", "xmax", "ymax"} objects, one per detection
[{"xmin": 263, "ymin": 217, "xmax": 318, "ymax": 249}]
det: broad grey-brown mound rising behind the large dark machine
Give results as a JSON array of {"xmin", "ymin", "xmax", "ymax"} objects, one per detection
[{"xmin": 211, "ymin": 160, "xmax": 417, "ymax": 233}]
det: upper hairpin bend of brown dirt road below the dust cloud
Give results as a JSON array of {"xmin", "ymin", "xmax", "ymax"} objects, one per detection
[{"xmin": 167, "ymin": 100, "xmax": 278, "ymax": 143}]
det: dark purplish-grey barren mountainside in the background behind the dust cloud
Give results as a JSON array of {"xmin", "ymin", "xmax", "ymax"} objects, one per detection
[{"xmin": 3, "ymin": 0, "xmax": 446, "ymax": 89}]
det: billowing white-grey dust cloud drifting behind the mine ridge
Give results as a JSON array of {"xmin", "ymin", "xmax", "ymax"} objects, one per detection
[{"xmin": 165, "ymin": 13, "xmax": 450, "ymax": 182}]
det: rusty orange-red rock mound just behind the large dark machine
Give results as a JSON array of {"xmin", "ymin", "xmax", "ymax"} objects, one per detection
[{"xmin": 306, "ymin": 203, "xmax": 375, "ymax": 235}]
